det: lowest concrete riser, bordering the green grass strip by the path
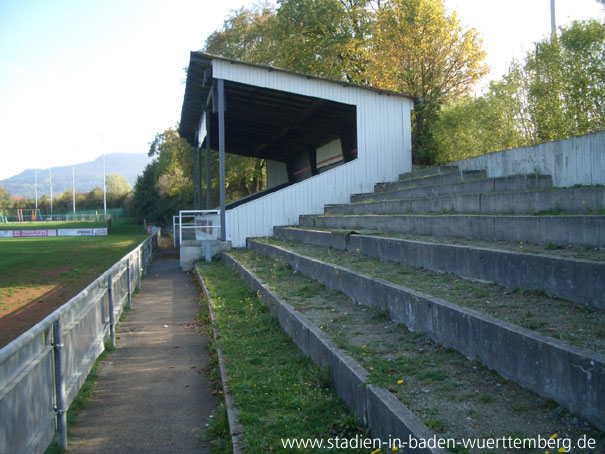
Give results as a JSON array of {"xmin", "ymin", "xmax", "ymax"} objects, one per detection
[{"xmin": 222, "ymin": 253, "xmax": 446, "ymax": 454}]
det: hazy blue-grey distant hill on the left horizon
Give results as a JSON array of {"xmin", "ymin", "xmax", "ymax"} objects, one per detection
[{"xmin": 0, "ymin": 153, "xmax": 151, "ymax": 197}]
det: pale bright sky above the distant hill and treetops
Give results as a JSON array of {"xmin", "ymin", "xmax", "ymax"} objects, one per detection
[{"xmin": 0, "ymin": 0, "xmax": 604, "ymax": 180}]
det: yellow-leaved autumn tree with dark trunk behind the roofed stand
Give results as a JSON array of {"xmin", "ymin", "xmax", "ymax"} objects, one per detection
[{"xmin": 368, "ymin": 0, "xmax": 488, "ymax": 163}]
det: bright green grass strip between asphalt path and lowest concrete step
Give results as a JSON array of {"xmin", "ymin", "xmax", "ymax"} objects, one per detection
[{"xmin": 198, "ymin": 262, "xmax": 367, "ymax": 454}]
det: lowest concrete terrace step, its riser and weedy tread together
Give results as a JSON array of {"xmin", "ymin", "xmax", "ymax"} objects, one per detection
[{"xmin": 223, "ymin": 250, "xmax": 605, "ymax": 454}]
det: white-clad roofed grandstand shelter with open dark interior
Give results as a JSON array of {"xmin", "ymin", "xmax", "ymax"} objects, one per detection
[{"xmin": 179, "ymin": 52, "xmax": 414, "ymax": 247}]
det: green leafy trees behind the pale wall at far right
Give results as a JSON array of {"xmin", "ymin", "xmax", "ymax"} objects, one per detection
[{"xmin": 433, "ymin": 20, "xmax": 605, "ymax": 162}]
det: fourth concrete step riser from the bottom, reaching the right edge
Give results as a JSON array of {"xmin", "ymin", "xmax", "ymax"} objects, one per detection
[{"xmin": 300, "ymin": 215, "xmax": 605, "ymax": 248}]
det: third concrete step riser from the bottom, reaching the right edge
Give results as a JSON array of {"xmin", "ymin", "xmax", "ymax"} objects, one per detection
[{"xmin": 274, "ymin": 227, "xmax": 605, "ymax": 309}]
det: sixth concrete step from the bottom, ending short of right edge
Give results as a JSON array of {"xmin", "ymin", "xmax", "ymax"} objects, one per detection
[{"xmin": 351, "ymin": 175, "xmax": 552, "ymax": 203}]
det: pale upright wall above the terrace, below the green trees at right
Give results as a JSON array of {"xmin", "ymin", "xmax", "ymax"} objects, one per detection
[{"xmin": 451, "ymin": 131, "xmax": 605, "ymax": 187}]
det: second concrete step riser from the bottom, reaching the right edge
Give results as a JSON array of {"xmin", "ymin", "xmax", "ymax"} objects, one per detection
[{"xmin": 248, "ymin": 240, "xmax": 605, "ymax": 429}]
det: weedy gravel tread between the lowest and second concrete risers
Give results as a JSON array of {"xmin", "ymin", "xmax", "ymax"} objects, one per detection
[{"xmin": 230, "ymin": 251, "xmax": 605, "ymax": 453}]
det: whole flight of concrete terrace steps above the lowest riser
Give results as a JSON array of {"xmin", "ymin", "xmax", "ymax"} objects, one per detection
[{"xmin": 228, "ymin": 166, "xmax": 605, "ymax": 446}]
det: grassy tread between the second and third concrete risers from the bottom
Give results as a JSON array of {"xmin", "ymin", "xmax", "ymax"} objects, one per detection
[{"xmin": 259, "ymin": 238, "xmax": 605, "ymax": 354}]
